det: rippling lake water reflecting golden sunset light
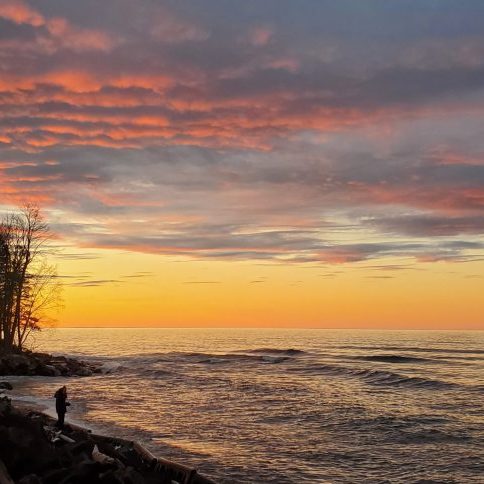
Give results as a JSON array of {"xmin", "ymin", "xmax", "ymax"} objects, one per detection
[{"xmin": 4, "ymin": 329, "xmax": 484, "ymax": 484}]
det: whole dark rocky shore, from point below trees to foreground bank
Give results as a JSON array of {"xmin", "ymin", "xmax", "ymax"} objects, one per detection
[{"xmin": 0, "ymin": 352, "xmax": 215, "ymax": 484}]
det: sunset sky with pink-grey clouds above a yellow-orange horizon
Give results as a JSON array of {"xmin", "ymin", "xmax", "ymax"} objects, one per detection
[{"xmin": 0, "ymin": 0, "xmax": 484, "ymax": 329}]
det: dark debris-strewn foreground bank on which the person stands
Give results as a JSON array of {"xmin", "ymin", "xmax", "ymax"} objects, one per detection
[{"xmin": 0, "ymin": 395, "xmax": 215, "ymax": 484}]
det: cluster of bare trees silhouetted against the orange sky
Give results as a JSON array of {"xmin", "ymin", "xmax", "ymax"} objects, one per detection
[{"xmin": 0, "ymin": 205, "xmax": 59, "ymax": 352}]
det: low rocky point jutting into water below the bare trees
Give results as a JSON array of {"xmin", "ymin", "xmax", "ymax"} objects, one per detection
[{"xmin": 0, "ymin": 351, "xmax": 101, "ymax": 377}]
